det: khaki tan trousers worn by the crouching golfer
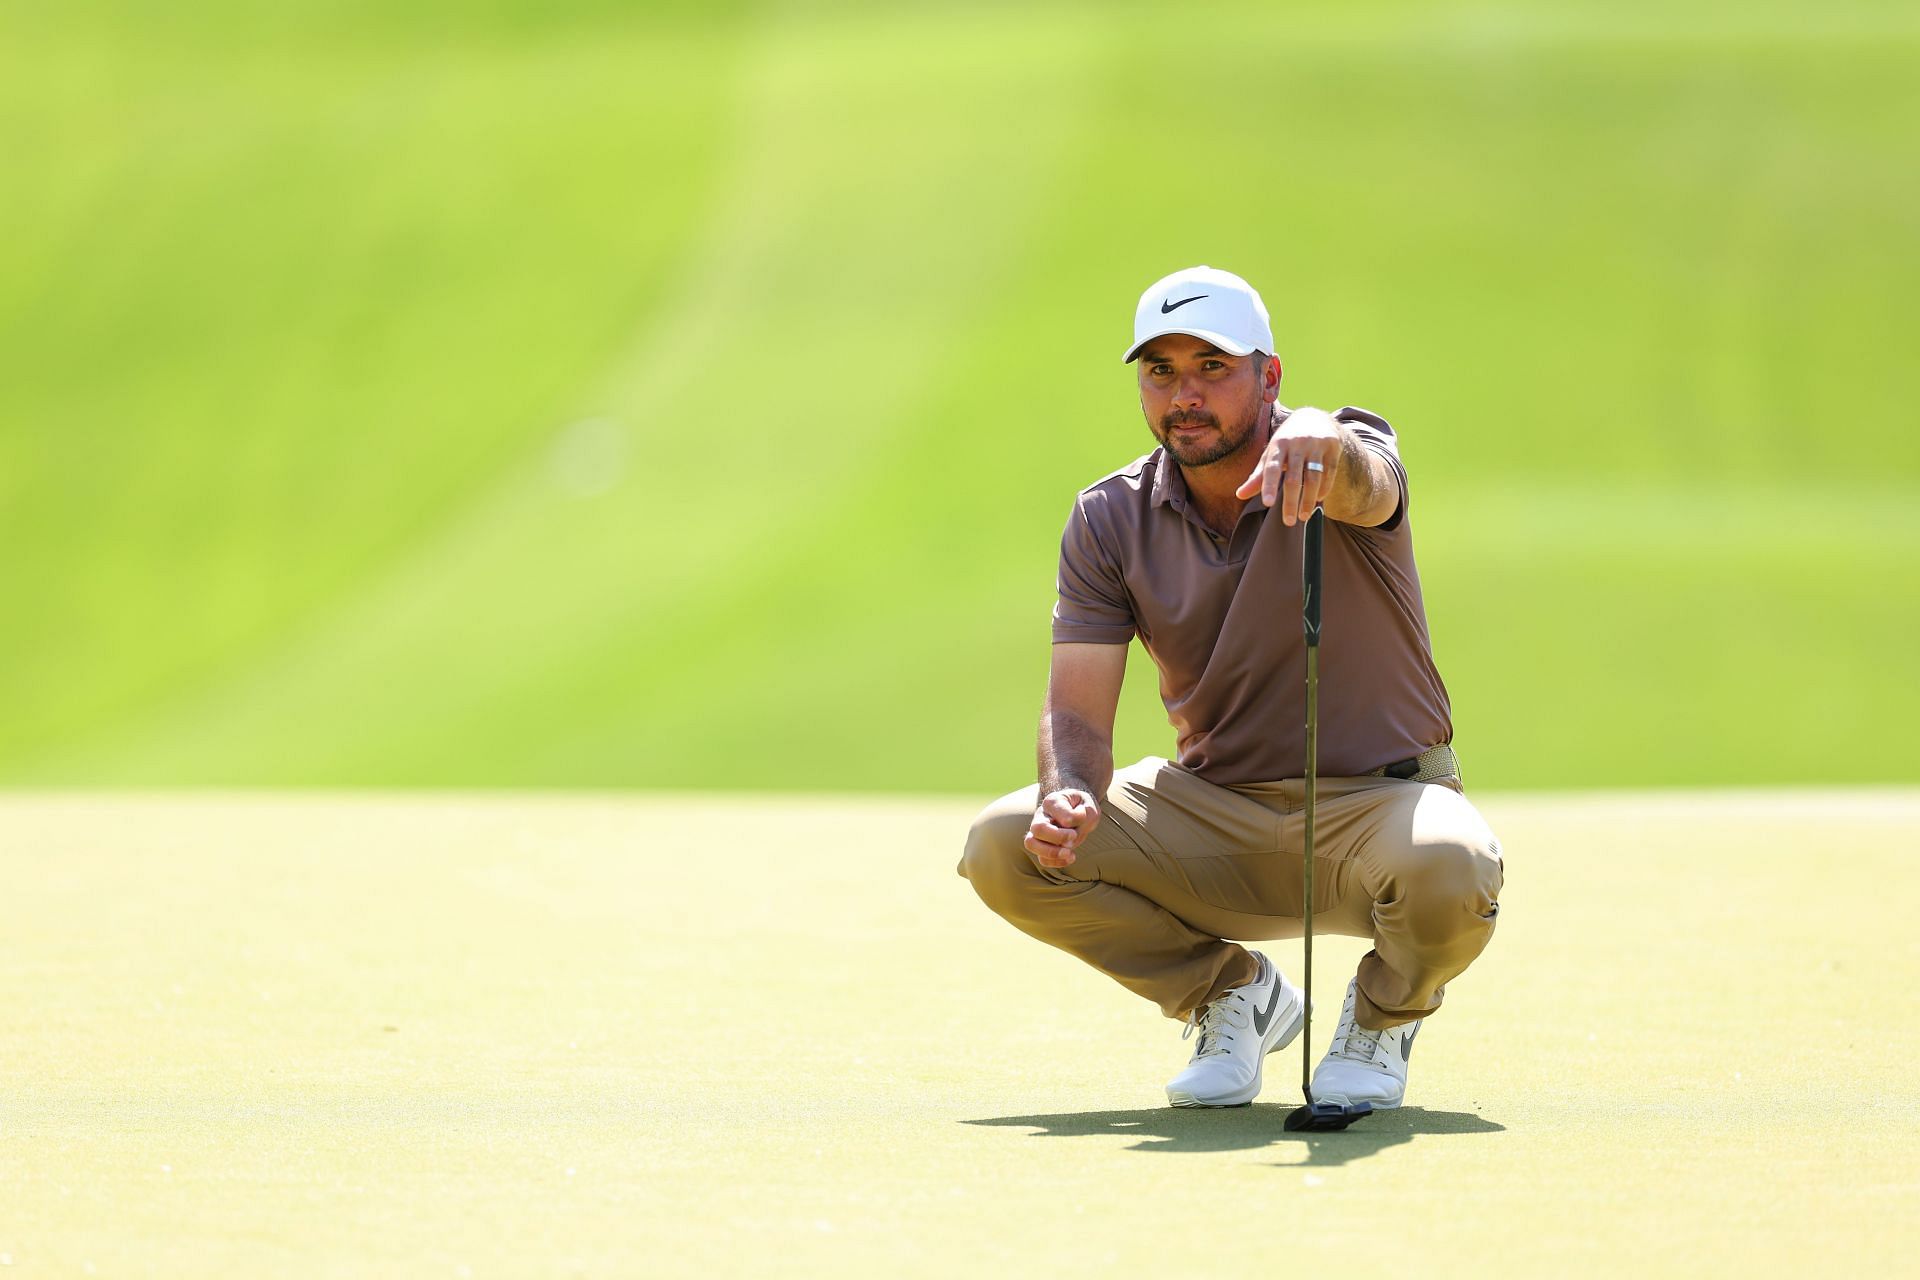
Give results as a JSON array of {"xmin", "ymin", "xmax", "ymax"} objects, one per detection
[{"xmin": 960, "ymin": 758, "xmax": 1501, "ymax": 1031}]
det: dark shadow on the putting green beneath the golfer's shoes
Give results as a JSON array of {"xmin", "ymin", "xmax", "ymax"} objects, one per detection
[{"xmin": 960, "ymin": 1103, "xmax": 1505, "ymax": 1169}]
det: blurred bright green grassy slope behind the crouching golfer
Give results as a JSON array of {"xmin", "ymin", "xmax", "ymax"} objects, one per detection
[{"xmin": 0, "ymin": 0, "xmax": 1920, "ymax": 793}]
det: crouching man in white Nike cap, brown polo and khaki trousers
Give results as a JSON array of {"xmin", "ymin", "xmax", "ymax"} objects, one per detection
[{"xmin": 960, "ymin": 267, "xmax": 1501, "ymax": 1109}]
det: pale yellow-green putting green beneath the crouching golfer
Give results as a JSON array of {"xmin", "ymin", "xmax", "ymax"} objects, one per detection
[{"xmin": 0, "ymin": 791, "xmax": 1920, "ymax": 1276}]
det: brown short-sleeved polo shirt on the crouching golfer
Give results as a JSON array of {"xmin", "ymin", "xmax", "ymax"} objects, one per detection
[{"xmin": 1054, "ymin": 407, "xmax": 1453, "ymax": 785}]
